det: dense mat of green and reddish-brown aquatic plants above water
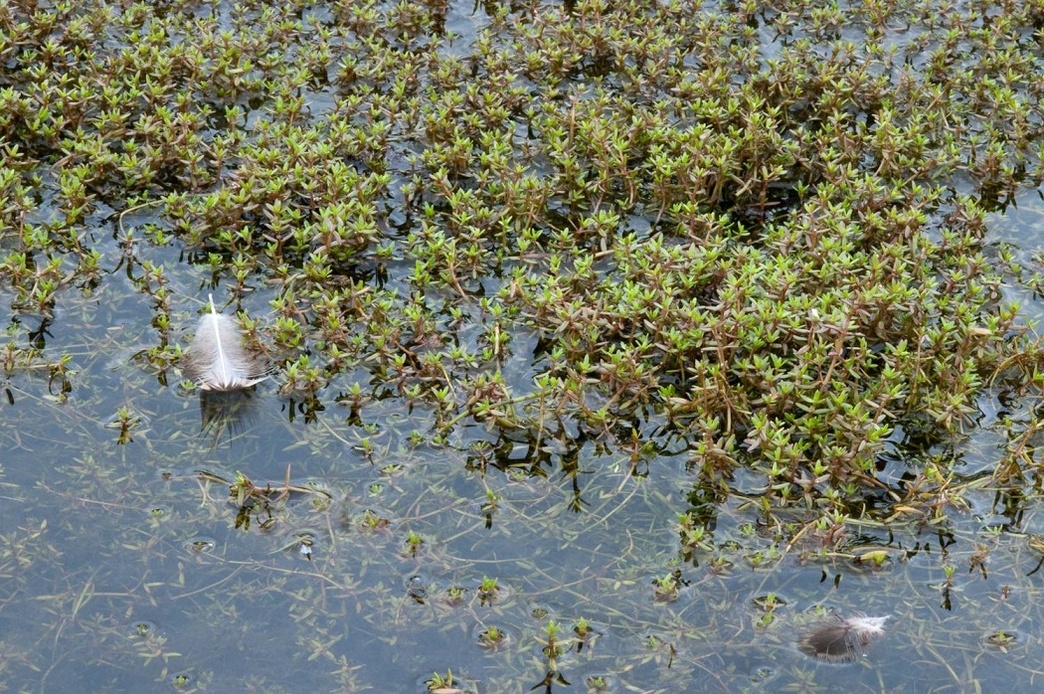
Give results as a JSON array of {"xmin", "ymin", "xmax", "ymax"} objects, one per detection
[{"xmin": 0, "ymin": 0, "xmax": 1044, "ymax": 496}]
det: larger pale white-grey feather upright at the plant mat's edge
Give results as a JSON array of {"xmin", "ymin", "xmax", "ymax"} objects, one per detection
[{"xmin": 183, "ymin": 296, "xmax": 271, "ymax": 392}]
